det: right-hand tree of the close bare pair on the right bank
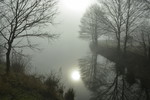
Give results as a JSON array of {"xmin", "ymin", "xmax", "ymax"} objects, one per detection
[{"xmin": 123, "ymin": 0, "xmax": 145, "ymax": 54}]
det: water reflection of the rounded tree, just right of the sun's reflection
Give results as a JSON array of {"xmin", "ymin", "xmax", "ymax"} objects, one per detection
[{"xmin": 79, "ymin": 53, "xmax": 99, "ymax": 90}]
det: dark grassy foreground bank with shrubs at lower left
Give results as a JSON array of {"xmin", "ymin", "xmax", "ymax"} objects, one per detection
[{"xmin": 0, "ymin": 64, "xmax": 63, "ymax": 100}]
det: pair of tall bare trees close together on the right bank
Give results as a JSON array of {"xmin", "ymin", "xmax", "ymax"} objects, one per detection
[{"xmin": 101, "ymin": 0, "xmax": 145, "ymax": 53}]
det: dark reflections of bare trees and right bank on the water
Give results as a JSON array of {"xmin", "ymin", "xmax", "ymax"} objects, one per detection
[{"xmin": 79, "ymin": 53, "xmax": 149, "ymax": 100}]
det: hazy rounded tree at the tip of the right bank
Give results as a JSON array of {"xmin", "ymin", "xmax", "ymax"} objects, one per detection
[{"xmin": 80, "ymin": 4, "xmax": 104, "ymax": 46}]
